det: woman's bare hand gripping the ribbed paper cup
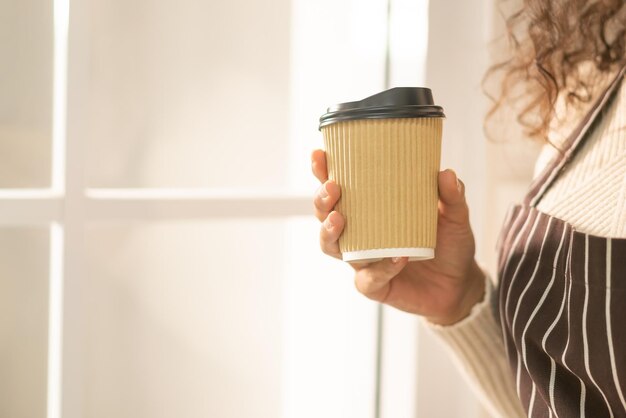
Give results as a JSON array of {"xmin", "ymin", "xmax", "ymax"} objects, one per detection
[{"xmin": 311, "ymin": 150, "xmax": 484, "ymax": 325}]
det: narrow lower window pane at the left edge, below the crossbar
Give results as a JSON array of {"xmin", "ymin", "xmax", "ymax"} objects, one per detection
[{"xmin": 0, "ymin": 228, "xmax": 48, "ymax": 418}]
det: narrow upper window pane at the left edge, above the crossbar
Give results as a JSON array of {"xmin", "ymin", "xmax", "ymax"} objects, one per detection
[{"xmin": 0, "ymin": 0, "xmax": 53, "ymax": 188}]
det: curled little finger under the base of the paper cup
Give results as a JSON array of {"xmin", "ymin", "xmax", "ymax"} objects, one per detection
[{"xmin": 354, "ymin": 257, "xmax": 408, "ymax": 302}]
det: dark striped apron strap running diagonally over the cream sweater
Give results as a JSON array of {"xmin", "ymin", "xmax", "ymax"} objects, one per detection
[{"xmin": 524, "ymin": 65, "xmax": 626, "ymax": 207}]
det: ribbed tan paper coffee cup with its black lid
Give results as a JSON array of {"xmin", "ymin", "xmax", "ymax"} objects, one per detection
[{"xmin": 320, "ymin": 87, "xmax": 445, "ymax": 262}]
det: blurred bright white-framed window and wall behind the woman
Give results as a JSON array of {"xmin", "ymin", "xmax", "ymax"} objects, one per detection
[{"xmin": 0, "ymin": 0, "xmax": 536, "ymax": 418}]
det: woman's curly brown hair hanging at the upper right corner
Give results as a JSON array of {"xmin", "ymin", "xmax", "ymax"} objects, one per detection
[{"xmin": 483, "ymin": 0, "xmax": 626, "ymax": 141}]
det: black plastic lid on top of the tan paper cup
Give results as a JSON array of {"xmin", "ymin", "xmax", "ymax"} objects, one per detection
[{"xmin": 320, "ymin": 87, "xmax": 445, "ymax": 129}]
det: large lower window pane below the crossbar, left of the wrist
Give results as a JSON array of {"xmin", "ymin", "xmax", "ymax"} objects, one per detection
[{"xmin": 83, "ymin": 220, "xmax": 375, "ymax": 418}]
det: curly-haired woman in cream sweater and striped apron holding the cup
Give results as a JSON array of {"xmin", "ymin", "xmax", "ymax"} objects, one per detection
[{"xmin": 312, "ymin": 0, "xmax": 626, "ymax": 417}]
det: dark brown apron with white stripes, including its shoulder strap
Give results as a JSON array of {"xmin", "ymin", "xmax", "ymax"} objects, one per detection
[{"xmin": 494, "ymin": 63, "xmax": 626, "ymax": 418}]
